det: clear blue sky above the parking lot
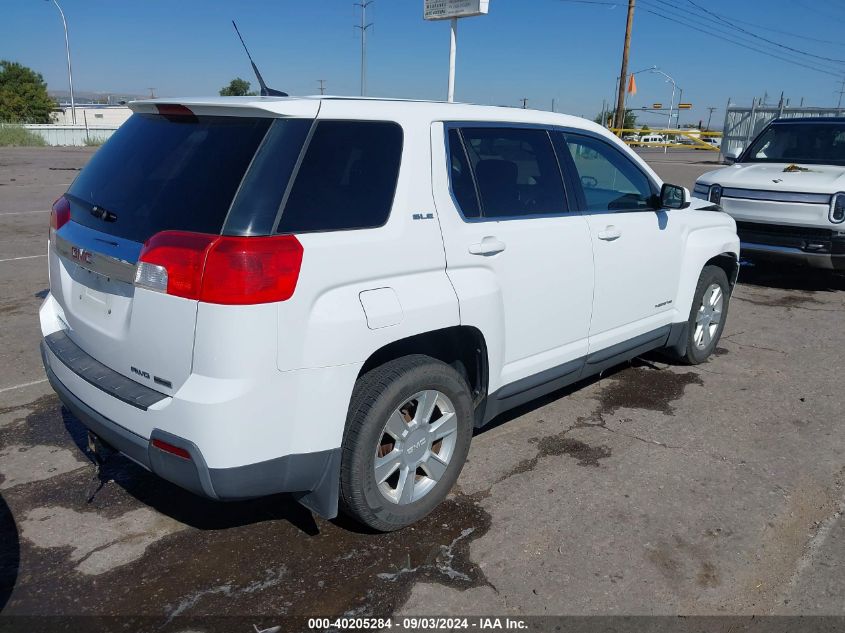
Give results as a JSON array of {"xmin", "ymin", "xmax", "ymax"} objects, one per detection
[{"xmin": 0, "ymin": 0, "xmax": 845, "ymax": 128}]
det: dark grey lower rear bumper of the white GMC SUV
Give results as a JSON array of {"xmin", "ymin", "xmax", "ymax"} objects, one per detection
[{"xmin": 41, "ymin": 340, "xmax": 340, "ymax": 518}]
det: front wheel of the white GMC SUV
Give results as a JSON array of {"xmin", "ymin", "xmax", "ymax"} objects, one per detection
[{"xmin": 681, "ymin": 266, "xmax": 731, "ymax": 365}]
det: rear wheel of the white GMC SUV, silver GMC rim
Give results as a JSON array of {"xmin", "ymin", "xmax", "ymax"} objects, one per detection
[{"xmin": 340, "ymin": 355, "xmax": 473, "ymax": 532}]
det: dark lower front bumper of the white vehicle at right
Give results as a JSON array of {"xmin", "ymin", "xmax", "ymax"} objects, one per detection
[{"xmin": 737, "ymin": 222, "xmax": 845, "ymax": 270}]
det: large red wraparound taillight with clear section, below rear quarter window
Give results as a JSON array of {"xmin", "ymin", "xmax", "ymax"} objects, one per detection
[{"xmin": 135, "ymin": 231, "xmax": 303, "ymax": 305}]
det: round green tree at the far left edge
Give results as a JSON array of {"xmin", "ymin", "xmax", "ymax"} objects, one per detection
[{"xmin": 0, "ymin": 59, "xmax": 56, "ymax": 123}]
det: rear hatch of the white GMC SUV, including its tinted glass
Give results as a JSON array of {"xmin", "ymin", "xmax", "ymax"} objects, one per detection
[{"xmin": 50, "ymin": 102, "xmax": 319, "ymax": 394}]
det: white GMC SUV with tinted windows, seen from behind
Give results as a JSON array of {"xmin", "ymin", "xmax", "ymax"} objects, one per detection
[{"xmin": 40, "ymin": 97, "xmax": 739, "ymax": 530}]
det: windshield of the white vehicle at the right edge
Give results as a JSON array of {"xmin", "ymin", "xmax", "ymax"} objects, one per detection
[{"xmin": 742, "ymin": 122, "xmax": 845, "ymax": 165}]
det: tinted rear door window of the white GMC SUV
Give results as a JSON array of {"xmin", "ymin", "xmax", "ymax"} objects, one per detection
[{"xmin": 461, "ymin": 128, "xmax": 566, "ymax": 218}]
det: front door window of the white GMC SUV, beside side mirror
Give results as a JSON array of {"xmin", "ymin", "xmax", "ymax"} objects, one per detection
[{"xmin": 565, "ymin": 136, "xmax": 652, "ymax": 211}]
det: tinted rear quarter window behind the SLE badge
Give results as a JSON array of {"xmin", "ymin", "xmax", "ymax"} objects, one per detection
[{"xmin": 276, "ymin": 121, "xmax": 402, "ymax": 233}]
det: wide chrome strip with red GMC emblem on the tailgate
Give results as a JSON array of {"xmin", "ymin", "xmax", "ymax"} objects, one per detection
[{"xmin": 55, "ymin": 222, "xmax": 141, "ymax": 284}]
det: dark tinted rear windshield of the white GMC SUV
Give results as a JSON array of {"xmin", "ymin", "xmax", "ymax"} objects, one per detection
[{"xmin": 68, "ymin": 114, "xmax": 273, "ymax": 242}]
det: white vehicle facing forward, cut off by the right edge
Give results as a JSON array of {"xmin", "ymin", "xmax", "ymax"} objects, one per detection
[{"xmin": 693, "ymin": 118, "xmax": 845, "ymax": 270}]
